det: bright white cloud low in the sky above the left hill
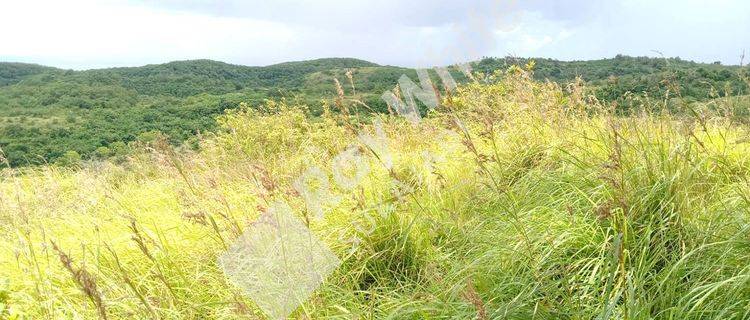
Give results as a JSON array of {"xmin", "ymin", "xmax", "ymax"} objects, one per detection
[{"xmin": 0, "ymin": 1, "xmax": 299, "ymax": 68}]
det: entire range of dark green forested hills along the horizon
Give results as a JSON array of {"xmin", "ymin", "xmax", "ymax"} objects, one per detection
[{"xmin": 0, "ymin": 56, "xmax": 747, "ymax": 166}]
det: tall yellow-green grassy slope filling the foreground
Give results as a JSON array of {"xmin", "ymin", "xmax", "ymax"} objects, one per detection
[{"xmin": 0, "ymin": 71, "xmax": 750, "ymax": 319}]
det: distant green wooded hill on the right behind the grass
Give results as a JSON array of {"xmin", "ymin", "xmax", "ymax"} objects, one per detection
[{"xmin": 474, "ymin": 55, "xmax": 750, "ymax": 106}]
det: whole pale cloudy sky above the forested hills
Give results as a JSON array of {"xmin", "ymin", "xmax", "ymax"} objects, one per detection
[{"xmin": 0, "ymin": 0, "xmax": 750, "ymax": 70}]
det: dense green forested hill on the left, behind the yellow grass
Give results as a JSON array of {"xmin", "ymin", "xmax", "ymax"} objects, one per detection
[{"xmin": 0, "ymin": 59, "xmax": 413, "ymax": 166}]
